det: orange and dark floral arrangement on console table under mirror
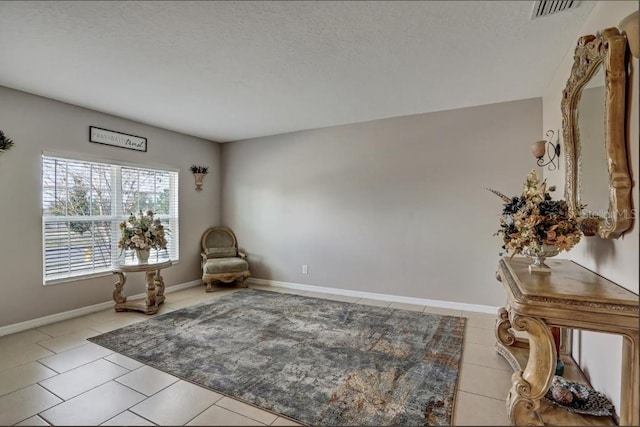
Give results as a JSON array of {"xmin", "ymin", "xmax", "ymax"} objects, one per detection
[{"xmin": 487, "ymin": 170, "xmax": 582, "ymax": 272}]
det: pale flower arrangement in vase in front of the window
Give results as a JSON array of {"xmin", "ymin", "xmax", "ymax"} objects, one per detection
[{"xmin": 118, "ymin": 210, "xmax": 167, "ymax": 263}]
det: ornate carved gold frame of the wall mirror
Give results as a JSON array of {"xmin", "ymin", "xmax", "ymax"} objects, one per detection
[{"xmin": 561, "ymin": 28, "xmax": 633, "ymax": 239}]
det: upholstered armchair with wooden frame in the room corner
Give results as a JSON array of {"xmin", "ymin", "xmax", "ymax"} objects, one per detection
[{"xmin": 201, "ymin": 227, "xmax": 251, "ymax": 292}]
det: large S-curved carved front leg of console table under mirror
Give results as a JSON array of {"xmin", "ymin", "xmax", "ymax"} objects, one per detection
[{"xmin": 507, "ymin": 312, "xmax": 556, "ymax": 426}]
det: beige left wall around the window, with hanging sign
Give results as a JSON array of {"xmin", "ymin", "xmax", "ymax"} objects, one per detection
[{"xmin": 0, "ymin": 86, "xmax": 220, "ymax": 326}]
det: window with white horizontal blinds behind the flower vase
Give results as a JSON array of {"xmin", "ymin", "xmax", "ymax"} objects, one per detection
[{"xmin": 42, "ymin": 155, "xmax": 178, "ymax": 284}]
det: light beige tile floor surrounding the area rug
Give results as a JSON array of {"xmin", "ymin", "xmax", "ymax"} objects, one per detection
[{"xmin": 0, "ymin": 285, "xmax": 511, "ymax": 426}]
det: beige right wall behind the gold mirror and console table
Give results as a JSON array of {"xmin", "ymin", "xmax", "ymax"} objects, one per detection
[{"xmin": 543, "ymin": 1, "xmax": 640, "ymax": 414}]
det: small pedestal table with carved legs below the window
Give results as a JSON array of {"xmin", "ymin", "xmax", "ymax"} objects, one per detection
[{"xmin": 111, "ymin": 261, "xmax": 172, "ymax": 314}]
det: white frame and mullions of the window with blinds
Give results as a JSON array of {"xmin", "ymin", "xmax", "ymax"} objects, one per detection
[{"xmin": 40, "ymin": 152, "xmax": 180, "ymax": 285}]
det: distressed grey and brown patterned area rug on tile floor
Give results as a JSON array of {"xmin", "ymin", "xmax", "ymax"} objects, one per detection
[{"xmin": 89, "ymin": 289, "xmax": 465, "ymax": 426}]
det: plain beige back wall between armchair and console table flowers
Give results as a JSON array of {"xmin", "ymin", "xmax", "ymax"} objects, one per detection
[{"xmin": 222, "ymin": 98, "xmax": 542, "ymax": 306}]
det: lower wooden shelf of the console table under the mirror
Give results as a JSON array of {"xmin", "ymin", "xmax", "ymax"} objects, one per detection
[{"xmin": 496, "ymin": 338, "xmax": 617, "ymax": 426}]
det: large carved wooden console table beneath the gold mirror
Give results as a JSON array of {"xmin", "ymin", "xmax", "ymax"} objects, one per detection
[{"xmin": 496, "ymin": 257, "xmax": 640, "ymax": 425}]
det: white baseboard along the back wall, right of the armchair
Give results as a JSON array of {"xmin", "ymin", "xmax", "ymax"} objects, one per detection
[{"xmin": 247, "ymin": 277, "xmax": 498, "ymax": 314}]
